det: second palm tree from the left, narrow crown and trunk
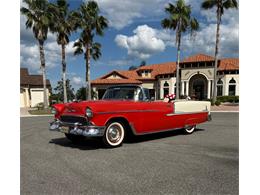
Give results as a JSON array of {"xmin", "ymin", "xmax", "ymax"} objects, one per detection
[{"xmin": 50, "ymin": 0, "xmax": 73, "ymax": 103}]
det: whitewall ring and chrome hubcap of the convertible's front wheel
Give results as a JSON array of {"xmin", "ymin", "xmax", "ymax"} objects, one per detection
[{"xmin": 106, "ymin": 122, "xmax": 125, "ymax": 146}]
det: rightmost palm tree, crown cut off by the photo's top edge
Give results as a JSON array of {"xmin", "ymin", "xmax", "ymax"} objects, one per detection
[{"xmin": 201, "ymin": 0, "xmax": 238, "ymax": 104}]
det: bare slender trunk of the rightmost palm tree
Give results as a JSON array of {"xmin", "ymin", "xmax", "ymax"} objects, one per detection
[{"xmin": 212, "ymin": 7, "xmax": 221, "ymax": 104}]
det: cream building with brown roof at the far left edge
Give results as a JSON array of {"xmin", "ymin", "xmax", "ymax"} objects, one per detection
[{"xmin": 20, "ymin": 68, "xmax": 51, "ymax": 107}]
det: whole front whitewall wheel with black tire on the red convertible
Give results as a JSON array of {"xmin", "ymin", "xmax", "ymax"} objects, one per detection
[{"xmin": 103, "ymin": 122, "xmax": 125, "ymax": 147}]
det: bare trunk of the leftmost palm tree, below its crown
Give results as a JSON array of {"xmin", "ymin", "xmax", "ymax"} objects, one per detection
[{"xmin": 39, "ymin": 40, "xmax": 48, "ymax": 109}]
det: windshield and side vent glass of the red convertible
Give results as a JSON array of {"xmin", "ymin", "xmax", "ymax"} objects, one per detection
[{"xmin": 102, "ymin": 87, "xmax": 143, "ymax": 101}]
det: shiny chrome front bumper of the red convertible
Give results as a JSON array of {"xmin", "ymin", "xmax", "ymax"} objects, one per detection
[{"xmin": 49, "ymin": 119, "xmax": 105, "ymax": 137}]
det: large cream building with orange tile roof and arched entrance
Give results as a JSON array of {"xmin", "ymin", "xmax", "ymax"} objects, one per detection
[{"xmin": 91, "ymin": 54, "xmax": 239, "ymax": 100}]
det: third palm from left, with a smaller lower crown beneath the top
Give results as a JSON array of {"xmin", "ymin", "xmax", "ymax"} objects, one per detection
[{"xmin": 72, "ymin": 1, "xmax": 108, "ymax": 100}]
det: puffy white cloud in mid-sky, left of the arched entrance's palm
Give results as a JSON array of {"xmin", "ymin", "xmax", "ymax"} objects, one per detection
[{"xmin": 115, "ymin": 25, "xmax": 173, "ymax": 59}]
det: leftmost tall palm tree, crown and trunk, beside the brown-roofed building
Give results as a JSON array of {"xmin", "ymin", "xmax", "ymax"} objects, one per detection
[{"xmin": 20, "ymin": 0, "xmax": 52, "ymax": 109}]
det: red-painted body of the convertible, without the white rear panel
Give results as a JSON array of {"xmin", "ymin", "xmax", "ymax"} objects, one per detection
[{"xmin": 51, "ymin": 84, "xmax": 210, "ymax": 147}]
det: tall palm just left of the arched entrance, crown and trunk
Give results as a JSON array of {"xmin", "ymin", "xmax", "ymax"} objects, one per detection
[{"xmin": 161, "ymin": 0, "xmax": 199, "ymax": 99}]
